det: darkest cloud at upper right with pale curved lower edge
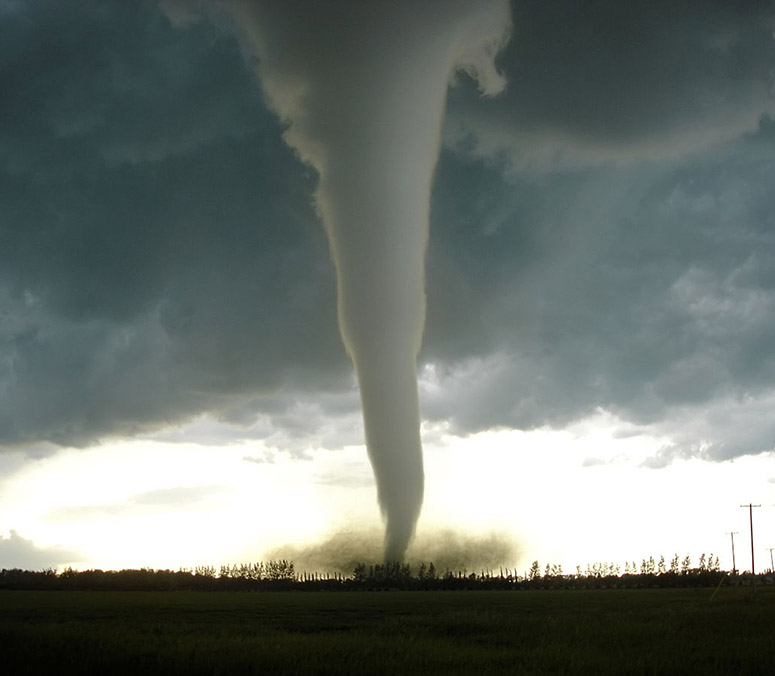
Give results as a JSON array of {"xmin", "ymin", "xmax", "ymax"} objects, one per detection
[{"xmin": 447, "ymin": 0, "xmax": 775, "ymax": 169}]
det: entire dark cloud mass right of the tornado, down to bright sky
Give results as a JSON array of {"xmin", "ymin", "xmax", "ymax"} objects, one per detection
[{"xmin": 423, "ymin": 2, "xmax": 775, "ymax": 464}]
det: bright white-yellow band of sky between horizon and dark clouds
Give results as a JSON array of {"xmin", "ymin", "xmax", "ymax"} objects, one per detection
[{"xmin": 6, "ymin": 415, "xmax": 775, "ymax": 572}]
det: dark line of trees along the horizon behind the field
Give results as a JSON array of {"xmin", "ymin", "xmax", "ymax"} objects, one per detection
[{"xmin": 0, "ymin": 554, "xmax": 772, "ymax": 591}]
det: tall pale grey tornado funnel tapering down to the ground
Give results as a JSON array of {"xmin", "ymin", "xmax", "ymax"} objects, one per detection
[{"xmin": 223, "ymin": 0, "xmax": 511, "ymax": 561}]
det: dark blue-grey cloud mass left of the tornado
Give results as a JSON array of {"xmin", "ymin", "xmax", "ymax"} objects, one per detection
[{"xmin": 0, "ymin": 3, "xmax": 347, "ymax": 444}]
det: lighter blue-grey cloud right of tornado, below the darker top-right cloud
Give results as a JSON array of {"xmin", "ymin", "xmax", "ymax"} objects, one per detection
[{"xmin": 423, "ymin": 119, "xmax": 775, "ymax": 454}]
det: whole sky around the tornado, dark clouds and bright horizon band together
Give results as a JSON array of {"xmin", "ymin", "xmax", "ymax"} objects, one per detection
[{"xmin": 0, "ymin": 0, "xmax": 775, "ymax": 572}]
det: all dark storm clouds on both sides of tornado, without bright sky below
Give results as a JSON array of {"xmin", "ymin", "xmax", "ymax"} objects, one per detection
[{"xmin": 0, "ymin": 2, "xmax": 775, "ymax": 465}]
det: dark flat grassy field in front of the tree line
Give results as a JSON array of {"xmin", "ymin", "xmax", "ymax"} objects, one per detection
[{"xmin": 0, "ymin": 588, "xmax": 775, "ymax": 676}]
